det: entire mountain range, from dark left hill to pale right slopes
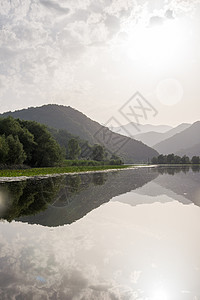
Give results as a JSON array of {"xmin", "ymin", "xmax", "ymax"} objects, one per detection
[{"xmin": 0, "ymin": 104, "xmax": 200, "ymax": 159}]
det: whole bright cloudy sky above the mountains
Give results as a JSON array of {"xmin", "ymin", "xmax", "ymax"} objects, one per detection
[{"xmin": 0, "ymin": 0, "xmax": 200, "ymax": 126}]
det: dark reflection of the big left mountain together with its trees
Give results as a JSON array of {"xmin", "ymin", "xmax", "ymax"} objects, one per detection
[{"xmin": 0, "ymin": 169, "xmax": 158, "ymax": 226}]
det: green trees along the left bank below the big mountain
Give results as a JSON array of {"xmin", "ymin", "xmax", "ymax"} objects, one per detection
[{"xmin": 0, "ymin": 116, "xmax": 123, "ymax": 168}]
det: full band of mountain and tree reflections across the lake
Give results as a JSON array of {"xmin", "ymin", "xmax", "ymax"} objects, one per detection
[{"xmin": 0, "ymin": 167, "xmax": 200, "ymax": 226}]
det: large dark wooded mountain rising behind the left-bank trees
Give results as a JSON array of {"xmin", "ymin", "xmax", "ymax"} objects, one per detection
[{"xmin": 0, "ymin": 104, "xmax": 158, "ymax": 163}]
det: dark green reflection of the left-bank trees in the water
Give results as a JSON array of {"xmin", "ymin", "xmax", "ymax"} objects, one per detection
[{"xmin": 0, "ymin": 174, "xmax": 103, "ymax": 222}]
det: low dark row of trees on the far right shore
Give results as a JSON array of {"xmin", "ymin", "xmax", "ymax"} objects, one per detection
[{"xmin": 151, "ymin": 153, "xmax": 200, "ymax": 165}]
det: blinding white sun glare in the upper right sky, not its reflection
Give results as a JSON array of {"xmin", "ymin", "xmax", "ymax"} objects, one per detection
[{"xmin": 125, "ymin": 20, "xmax": 185, "ymax": 68}]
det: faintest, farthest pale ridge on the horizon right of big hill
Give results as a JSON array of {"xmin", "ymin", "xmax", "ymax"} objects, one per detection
[{"xmin": 112, "ymin": 123, "xmax": 172, "ymax": 137}]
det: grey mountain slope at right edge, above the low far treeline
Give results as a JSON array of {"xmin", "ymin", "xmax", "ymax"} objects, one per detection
[{"xmin": 154, "ymin": 121, "xmax": 200, "ymax": 154}]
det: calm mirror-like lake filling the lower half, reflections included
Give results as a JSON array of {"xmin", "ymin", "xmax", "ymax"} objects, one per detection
[{"xmin": 0, "ymin": 167, "xmax": 200, "ymax": 300}]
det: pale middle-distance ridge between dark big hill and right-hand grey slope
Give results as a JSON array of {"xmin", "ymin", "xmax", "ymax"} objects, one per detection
[{"xmin": 134, "ymin": 123, "xmax": 191, "ymax": 147}]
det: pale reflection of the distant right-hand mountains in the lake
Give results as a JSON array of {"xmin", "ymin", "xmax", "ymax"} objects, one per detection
[{"xmin": 113, "ymin": 166, "xmax": 200, "ymax": 206}]
